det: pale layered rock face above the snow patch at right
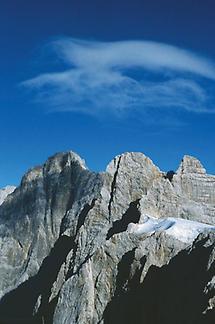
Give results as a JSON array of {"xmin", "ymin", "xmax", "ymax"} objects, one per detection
[{"xmin": 141, "ymin": 156, "xmax": 215, "ymax": 224}]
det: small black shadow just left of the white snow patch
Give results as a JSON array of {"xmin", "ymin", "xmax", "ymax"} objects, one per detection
[{"xmin": 106, "ymin": 199, "xmax": 141, "ymax": 240}]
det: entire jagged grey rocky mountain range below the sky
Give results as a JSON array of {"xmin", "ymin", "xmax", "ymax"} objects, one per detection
[{"xmin": 0, "ymin": 152, "xmax": 215, "ymax": 324}]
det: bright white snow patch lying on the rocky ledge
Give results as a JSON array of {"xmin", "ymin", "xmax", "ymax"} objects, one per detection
[{"xmin": 127, "ymin": 216, "xmax": 215, "ymax": 243}]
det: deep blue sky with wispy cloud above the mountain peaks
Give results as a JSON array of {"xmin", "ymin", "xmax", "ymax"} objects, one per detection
[{"xmin": 0, "ymin": 0, "xmax": 215, "ymax": 187}]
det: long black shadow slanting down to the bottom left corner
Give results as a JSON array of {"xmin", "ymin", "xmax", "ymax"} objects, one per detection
[{"xmin": 0, "ymin": 236, "xmax": 74, "ymax": 324}]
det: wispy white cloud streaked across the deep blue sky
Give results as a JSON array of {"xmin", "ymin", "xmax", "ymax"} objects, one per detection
[{"xmin": 23, "ymin": 38, "xmax": 215, "ymax": 117}]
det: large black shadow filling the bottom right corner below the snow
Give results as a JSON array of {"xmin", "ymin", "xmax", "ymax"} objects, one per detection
[{"xmin": 104, "ymin": 237, "xmax": 215, "ymax": 324}]
